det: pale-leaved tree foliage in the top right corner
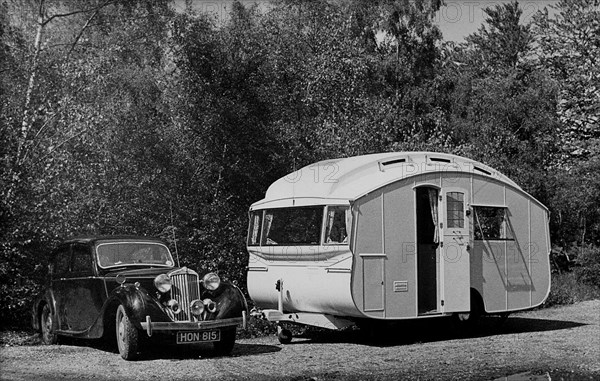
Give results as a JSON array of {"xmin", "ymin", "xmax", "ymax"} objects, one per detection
[{"xmin": 534, "ymin": 0, "xmax": 600, "ymax": 158}]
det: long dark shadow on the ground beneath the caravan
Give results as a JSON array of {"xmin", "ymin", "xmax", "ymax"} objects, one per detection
[{"xmin": 291, "ymin": 316, "xmax": 586, "ymax": 346}]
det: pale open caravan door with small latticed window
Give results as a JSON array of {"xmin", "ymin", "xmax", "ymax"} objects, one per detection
[{"xmin": 440, "ymin": 188, "xmax": 471, "ymax": 313}]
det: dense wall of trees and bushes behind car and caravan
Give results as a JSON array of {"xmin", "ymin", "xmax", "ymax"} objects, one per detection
[{"xmin": 0, "ymin": 0, "xmax": 600, "ymax": 331}]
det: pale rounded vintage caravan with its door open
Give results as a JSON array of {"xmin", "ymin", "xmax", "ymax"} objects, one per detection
[{"xmin": 247, "ymin": 152, "xmax": 550, "ymax": 342}]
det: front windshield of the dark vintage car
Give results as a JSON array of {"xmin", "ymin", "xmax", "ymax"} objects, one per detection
[{"xmin": 96, "ymin": 242, "xmax": 173, "ymax": 268}]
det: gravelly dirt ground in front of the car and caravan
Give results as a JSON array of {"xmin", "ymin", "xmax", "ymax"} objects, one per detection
[{"xmin": 0, "ymin": 300, "xmax": 600, "ymax": 381}]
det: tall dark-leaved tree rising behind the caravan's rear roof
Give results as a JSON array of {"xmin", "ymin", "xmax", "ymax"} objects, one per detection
[{"xmin": 440, "ymin": 2, "xmax": 558, "ymax": 202}]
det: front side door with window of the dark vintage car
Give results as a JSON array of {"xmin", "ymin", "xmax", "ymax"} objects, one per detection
[{"xmin": 63, "ymin": 243, "xmax": 106, "ymax": 333}]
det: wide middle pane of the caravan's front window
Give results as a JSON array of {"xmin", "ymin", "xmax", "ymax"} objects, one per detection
[{"xmin": 261, "ymin": 206, "xmax": 323, "ymax": 246}]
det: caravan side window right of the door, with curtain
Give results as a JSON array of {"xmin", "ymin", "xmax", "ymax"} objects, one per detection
[{"xmin": 473, "ymin": 206, "xmax": 514, "ymax": 241}]
